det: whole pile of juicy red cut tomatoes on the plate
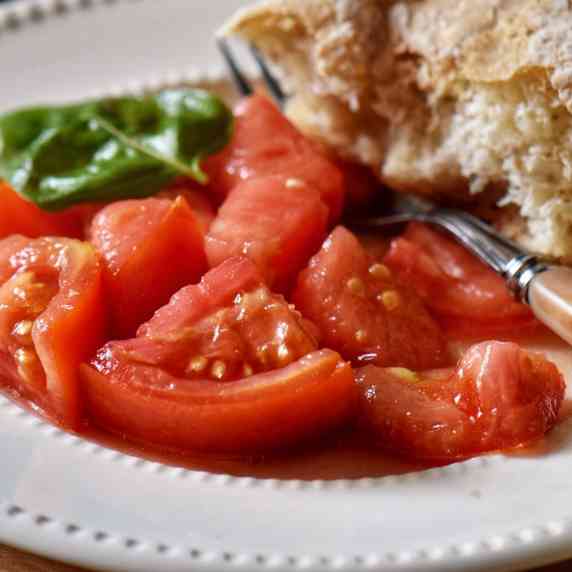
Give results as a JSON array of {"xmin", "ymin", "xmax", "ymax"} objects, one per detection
[{"xmin": 0, "ymin": 95, "xmax": 565, "ymax": 462}]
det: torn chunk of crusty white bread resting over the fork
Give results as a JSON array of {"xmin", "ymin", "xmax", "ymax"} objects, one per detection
[{"xmin": 224, "ymin": 0, "xmax": 572, "ymax": 261}]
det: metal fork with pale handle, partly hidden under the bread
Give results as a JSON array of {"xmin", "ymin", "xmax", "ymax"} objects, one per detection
[{"xmin": 217, "ymin": 37, "xmax": 572, "ymax": 344}]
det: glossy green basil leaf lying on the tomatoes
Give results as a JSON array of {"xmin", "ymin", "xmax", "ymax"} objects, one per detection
[{"xmin": 0, "ymin": 89, "xmax": 233, "ymax": 210}]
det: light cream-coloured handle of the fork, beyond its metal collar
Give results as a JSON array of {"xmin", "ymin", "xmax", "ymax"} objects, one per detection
[{"xmin": 528, "ymin": 266, "xmax": 572, "ymax": 344}]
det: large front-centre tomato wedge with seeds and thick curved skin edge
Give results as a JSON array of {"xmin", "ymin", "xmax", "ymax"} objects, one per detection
[{"xmin": 82, "ymin": 258, "xmax": 356, "ymax": 453}]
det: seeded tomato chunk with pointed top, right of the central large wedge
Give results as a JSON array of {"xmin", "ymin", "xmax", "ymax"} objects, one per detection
[{"xmin": 293, "ymin": 227, "xmax": 447, "ymax": 369}]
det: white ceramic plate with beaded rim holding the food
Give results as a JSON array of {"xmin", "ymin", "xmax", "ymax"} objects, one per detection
[{"xmin": 0, "ymin": 0, "xmax": 572, "ymax": 572}]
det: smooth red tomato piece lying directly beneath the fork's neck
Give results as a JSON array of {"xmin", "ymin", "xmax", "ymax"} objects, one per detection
[{"xmin": 385, "ymin": 223, "xmax": 536, "ymax": 335}]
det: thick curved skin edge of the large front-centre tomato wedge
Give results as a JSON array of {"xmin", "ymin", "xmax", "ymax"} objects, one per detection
[{"xmin": 82, "ymin": 350, "xmax": 355, "ymax": 454}]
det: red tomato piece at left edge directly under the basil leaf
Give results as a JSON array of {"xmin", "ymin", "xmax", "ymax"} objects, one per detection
[{"xmin": 0, "ymin": 181, "xmax": 82, "ymax": 238}]
